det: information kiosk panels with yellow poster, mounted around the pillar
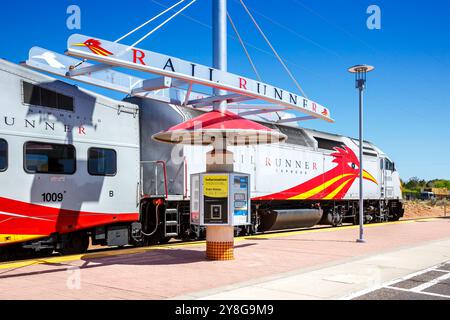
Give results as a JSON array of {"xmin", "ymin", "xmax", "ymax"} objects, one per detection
[{"xmin": 191, "ymin": 173, "xmax": 251, "ymax": 226}]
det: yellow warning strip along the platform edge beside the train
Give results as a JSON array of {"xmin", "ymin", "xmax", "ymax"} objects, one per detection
[{"xmin": 0, "ymin": 218, "xmax": 439, "ymax": 269}]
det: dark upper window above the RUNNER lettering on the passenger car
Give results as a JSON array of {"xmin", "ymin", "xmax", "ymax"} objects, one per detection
[{"xmin": 23, "ymin": 81, "xmax": 74, "ymax": 111}]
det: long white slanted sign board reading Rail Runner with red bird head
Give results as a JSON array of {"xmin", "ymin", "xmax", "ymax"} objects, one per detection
[{"xmin": 66, "ymin": 34, "xmax": 333, "ymax": 122}]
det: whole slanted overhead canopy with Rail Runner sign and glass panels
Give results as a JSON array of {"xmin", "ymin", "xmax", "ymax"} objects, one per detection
[{"xmin": 25, "ymin": 34, "xmax": 333, "ymax": 123}]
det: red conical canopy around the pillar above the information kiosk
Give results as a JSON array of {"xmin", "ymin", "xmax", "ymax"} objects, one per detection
[{"xmin": 152, "ymin": 110, "xmax": 287, "ymax": 146}]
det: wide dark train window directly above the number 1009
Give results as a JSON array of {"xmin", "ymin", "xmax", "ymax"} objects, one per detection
[{"xmin": 25, "ymin": 142, "xmax": 76, "ymax": 175}]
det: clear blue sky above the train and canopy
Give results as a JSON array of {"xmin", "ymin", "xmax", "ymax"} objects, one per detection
[{"xmin": 0, "ymin": 0, "xmax": 450, "ymax": 179}]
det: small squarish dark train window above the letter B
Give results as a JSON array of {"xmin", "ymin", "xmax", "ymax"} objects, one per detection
[{"xmin": 88, "ymin": 148, "xmax": 117, "ymax": 176}]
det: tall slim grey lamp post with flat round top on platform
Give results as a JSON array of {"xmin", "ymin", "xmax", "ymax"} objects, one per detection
[{"xmin": 348, "ymin": 65, "xmax": 375, "ymax": 243}]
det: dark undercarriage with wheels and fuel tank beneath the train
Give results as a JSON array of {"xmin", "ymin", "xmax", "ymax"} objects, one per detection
[{"xmin": 0, "ymin": 199, "xmax": 404, "ymax": 261}]
